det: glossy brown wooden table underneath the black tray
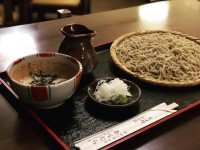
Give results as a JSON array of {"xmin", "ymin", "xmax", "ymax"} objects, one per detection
[{"xmin": 0, "ymin": 0, "xmax": 200, "ymax": 150}]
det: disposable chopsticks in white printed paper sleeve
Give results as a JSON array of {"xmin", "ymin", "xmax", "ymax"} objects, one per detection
[{"xmin": 74, "ymin": 103, "xmax": 179, "ymax": 150}]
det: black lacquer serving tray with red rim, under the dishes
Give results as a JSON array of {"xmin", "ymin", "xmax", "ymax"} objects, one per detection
[{"xmin": 0, "ymin": 44, "xmax": 200, "ymax": 149}]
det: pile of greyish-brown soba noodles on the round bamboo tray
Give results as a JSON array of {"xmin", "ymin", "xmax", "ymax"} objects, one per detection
[{"xmin": 116, "ymin": 32, "xmax": 200, "ymax": 82}]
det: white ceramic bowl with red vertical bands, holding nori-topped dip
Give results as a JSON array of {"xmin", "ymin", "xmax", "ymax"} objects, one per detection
[{"xmin": 7, "ymin": 53, "xmax": 82, "ymax": 108}]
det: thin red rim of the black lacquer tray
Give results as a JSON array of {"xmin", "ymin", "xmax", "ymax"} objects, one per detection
[{"xmin": 0, "ymin": 43, "xmax": 200, "ymax": 150}]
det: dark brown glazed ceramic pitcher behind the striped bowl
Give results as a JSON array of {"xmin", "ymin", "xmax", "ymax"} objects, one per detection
[{"xmin": 58, "ymin": 24, "xmax": 98, "ymax": 74}]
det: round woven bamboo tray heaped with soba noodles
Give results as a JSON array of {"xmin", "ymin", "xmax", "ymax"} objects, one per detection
[{"xmin": 110, "ymin": 30, "xmax": 200, "ymax": 87}]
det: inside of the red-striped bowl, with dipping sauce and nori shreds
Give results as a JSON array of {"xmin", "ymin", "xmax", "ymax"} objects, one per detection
[{"xmin": 10, "ymin": 61, "xmax": 78, "ymax": 86}]
